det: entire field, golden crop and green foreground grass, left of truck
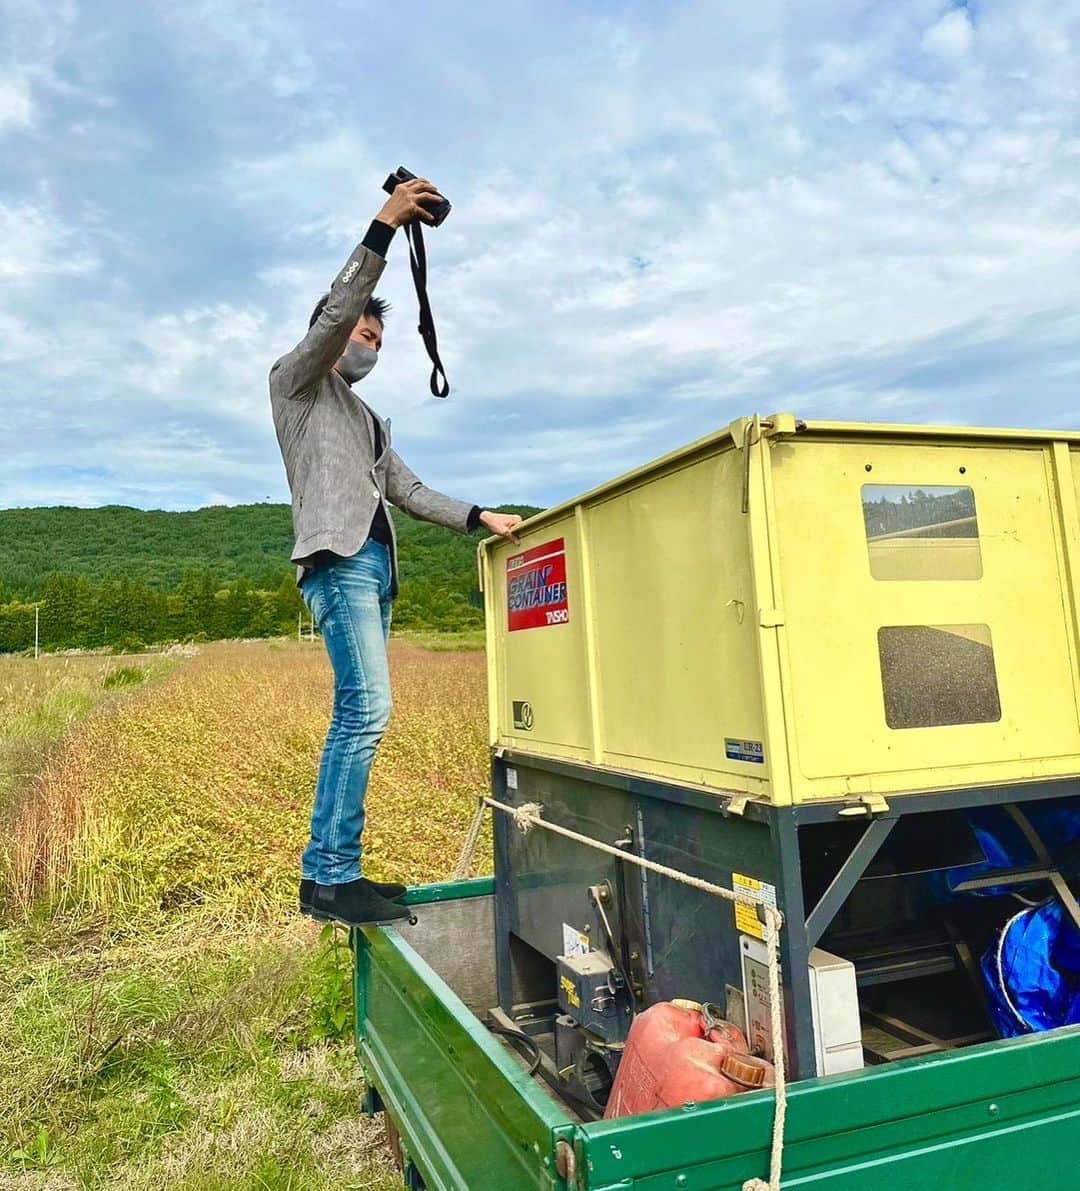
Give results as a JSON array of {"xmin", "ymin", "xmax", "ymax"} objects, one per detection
[{"xmin": 0, "ymin": 641, "xmax": 491, "ymax": 1191}]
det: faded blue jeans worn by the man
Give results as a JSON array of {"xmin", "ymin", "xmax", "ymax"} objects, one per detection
[{"xmin": 300, "ymin": 540, "xmax": 392, "ymax": 885}]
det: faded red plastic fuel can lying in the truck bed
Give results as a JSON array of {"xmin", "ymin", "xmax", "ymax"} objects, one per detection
[{"xmin": 604, "ymin": 1000, "xmax": 774, "ymax": 1120}]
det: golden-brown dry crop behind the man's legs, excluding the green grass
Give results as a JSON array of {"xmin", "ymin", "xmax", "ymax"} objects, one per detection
[{"xmin": 0, "ymin": 642, "xmax": 487, "ymax": 917}]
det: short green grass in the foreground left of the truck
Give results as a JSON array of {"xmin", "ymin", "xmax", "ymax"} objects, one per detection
[{"xmin": 0, "ymin": 918, "xmax": 400, "ymax": 1191}]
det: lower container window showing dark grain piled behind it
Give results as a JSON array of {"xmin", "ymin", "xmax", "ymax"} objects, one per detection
[{"xmin": 878, "ymin": 624, "xmax": 1001, "ymax": 728}]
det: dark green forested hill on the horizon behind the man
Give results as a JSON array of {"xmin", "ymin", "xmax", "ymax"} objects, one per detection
[{"xmin": 0, "ymin": 504, "xmax": 537, "ymax": 651}]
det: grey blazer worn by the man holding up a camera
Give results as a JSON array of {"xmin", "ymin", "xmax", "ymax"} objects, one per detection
[{"xmin": 270, "ymin": 244, "xmax": 473, "ymax": 593}]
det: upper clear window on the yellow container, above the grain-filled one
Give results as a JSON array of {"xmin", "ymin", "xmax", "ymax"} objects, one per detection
[{"xmin": 862, "ymin": 484, "xmax": 982, "ymax": 579}]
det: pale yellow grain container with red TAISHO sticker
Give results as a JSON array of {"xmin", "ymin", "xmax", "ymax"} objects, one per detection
[{"xmin": 480, "ymin": 413, "xmax": 1080, "ymax": 809}]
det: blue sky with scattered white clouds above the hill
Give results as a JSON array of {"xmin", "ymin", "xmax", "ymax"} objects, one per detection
[{"xmin": 0, "ymin": 0, "xmax": 1080, "ymax": 509}]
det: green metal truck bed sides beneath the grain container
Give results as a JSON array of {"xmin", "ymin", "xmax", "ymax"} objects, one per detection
[{"xmin": 354, "ymin": 879, "xmax": 1080, "ymax": 1191}]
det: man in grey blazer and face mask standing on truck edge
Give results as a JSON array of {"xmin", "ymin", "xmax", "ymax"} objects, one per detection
[{"xmin": 270, "ymin": 177, "xmax": 522, "ymax": 925}]
